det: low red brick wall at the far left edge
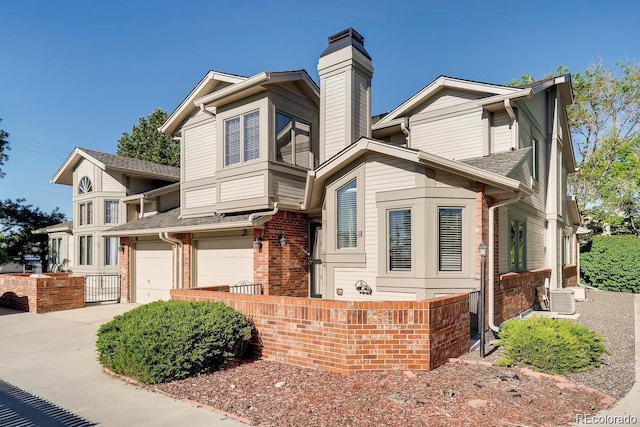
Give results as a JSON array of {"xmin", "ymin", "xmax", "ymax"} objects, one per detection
[{"xmin": 0, "ymin": 273, "xmax": 84, "ymax": 313}]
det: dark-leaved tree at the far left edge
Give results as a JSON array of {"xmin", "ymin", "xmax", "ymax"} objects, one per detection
[{"xmin": 0, "ymin": 199, "xmax": 65, "ymax": 271}]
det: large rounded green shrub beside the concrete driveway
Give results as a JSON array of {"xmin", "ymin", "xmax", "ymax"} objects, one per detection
[{"xmin": 96, "ymin": 301, "xmax": 251, "ymax": 384}]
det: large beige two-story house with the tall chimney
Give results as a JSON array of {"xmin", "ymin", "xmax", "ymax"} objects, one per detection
[{"xmin": 104, "ymin": 29, "xmax": 579, "ymax": 314}]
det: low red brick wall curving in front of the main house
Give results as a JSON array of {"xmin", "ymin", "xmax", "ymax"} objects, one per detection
[{"xmin": 171, "ymin": 287, "xmax": 469, "ymax": 374}]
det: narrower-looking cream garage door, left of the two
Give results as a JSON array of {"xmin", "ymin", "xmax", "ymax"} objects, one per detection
[{"xmin": 135, "ymin": 242, "xmax": 173, "ymax": 304}]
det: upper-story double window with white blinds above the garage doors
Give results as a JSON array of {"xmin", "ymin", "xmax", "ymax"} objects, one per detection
[{"xmin": 224, "ymin": 111, "xmax": 260, "ymax": 166}]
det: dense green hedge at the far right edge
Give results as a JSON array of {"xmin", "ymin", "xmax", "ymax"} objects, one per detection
[{"xmin": 580, "ymin": 236, "xmax": 640, "ymax": 293}]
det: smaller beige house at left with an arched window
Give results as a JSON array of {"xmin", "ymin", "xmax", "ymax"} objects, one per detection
[{"xmin": 44, "ymin": 148, "xmax": 180, "ymax": 275}]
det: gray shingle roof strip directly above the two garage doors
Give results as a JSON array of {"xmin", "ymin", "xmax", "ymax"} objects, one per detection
[{"xmin": 108, "ymin": 208, "xmax": 250, "ymax": 235}]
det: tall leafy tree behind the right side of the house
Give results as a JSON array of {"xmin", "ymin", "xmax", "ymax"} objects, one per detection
[{"xmin": 511, "ymin": 60, "xmax": 640, "ymax": 235}]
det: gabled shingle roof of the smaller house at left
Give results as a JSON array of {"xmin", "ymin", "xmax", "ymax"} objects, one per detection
[{"xmin": 51, "ymin": 147, "xmax": 180, "ymax": 185}]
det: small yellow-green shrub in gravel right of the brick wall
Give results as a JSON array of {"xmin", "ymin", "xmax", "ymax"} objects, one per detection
[{"xmin": 498, "ymin": 317, "xmax": 609, "ymax": 375}]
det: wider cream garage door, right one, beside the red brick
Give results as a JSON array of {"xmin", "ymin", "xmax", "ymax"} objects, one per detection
[{"xmin": 195, "ymin": 236, "xmax": 253, "ymax": 286}]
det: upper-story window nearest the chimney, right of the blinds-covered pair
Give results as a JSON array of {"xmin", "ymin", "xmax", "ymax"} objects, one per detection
[{"xmin": 276, "ymin": 111, "xmax": 313, "ymax": 169}]
